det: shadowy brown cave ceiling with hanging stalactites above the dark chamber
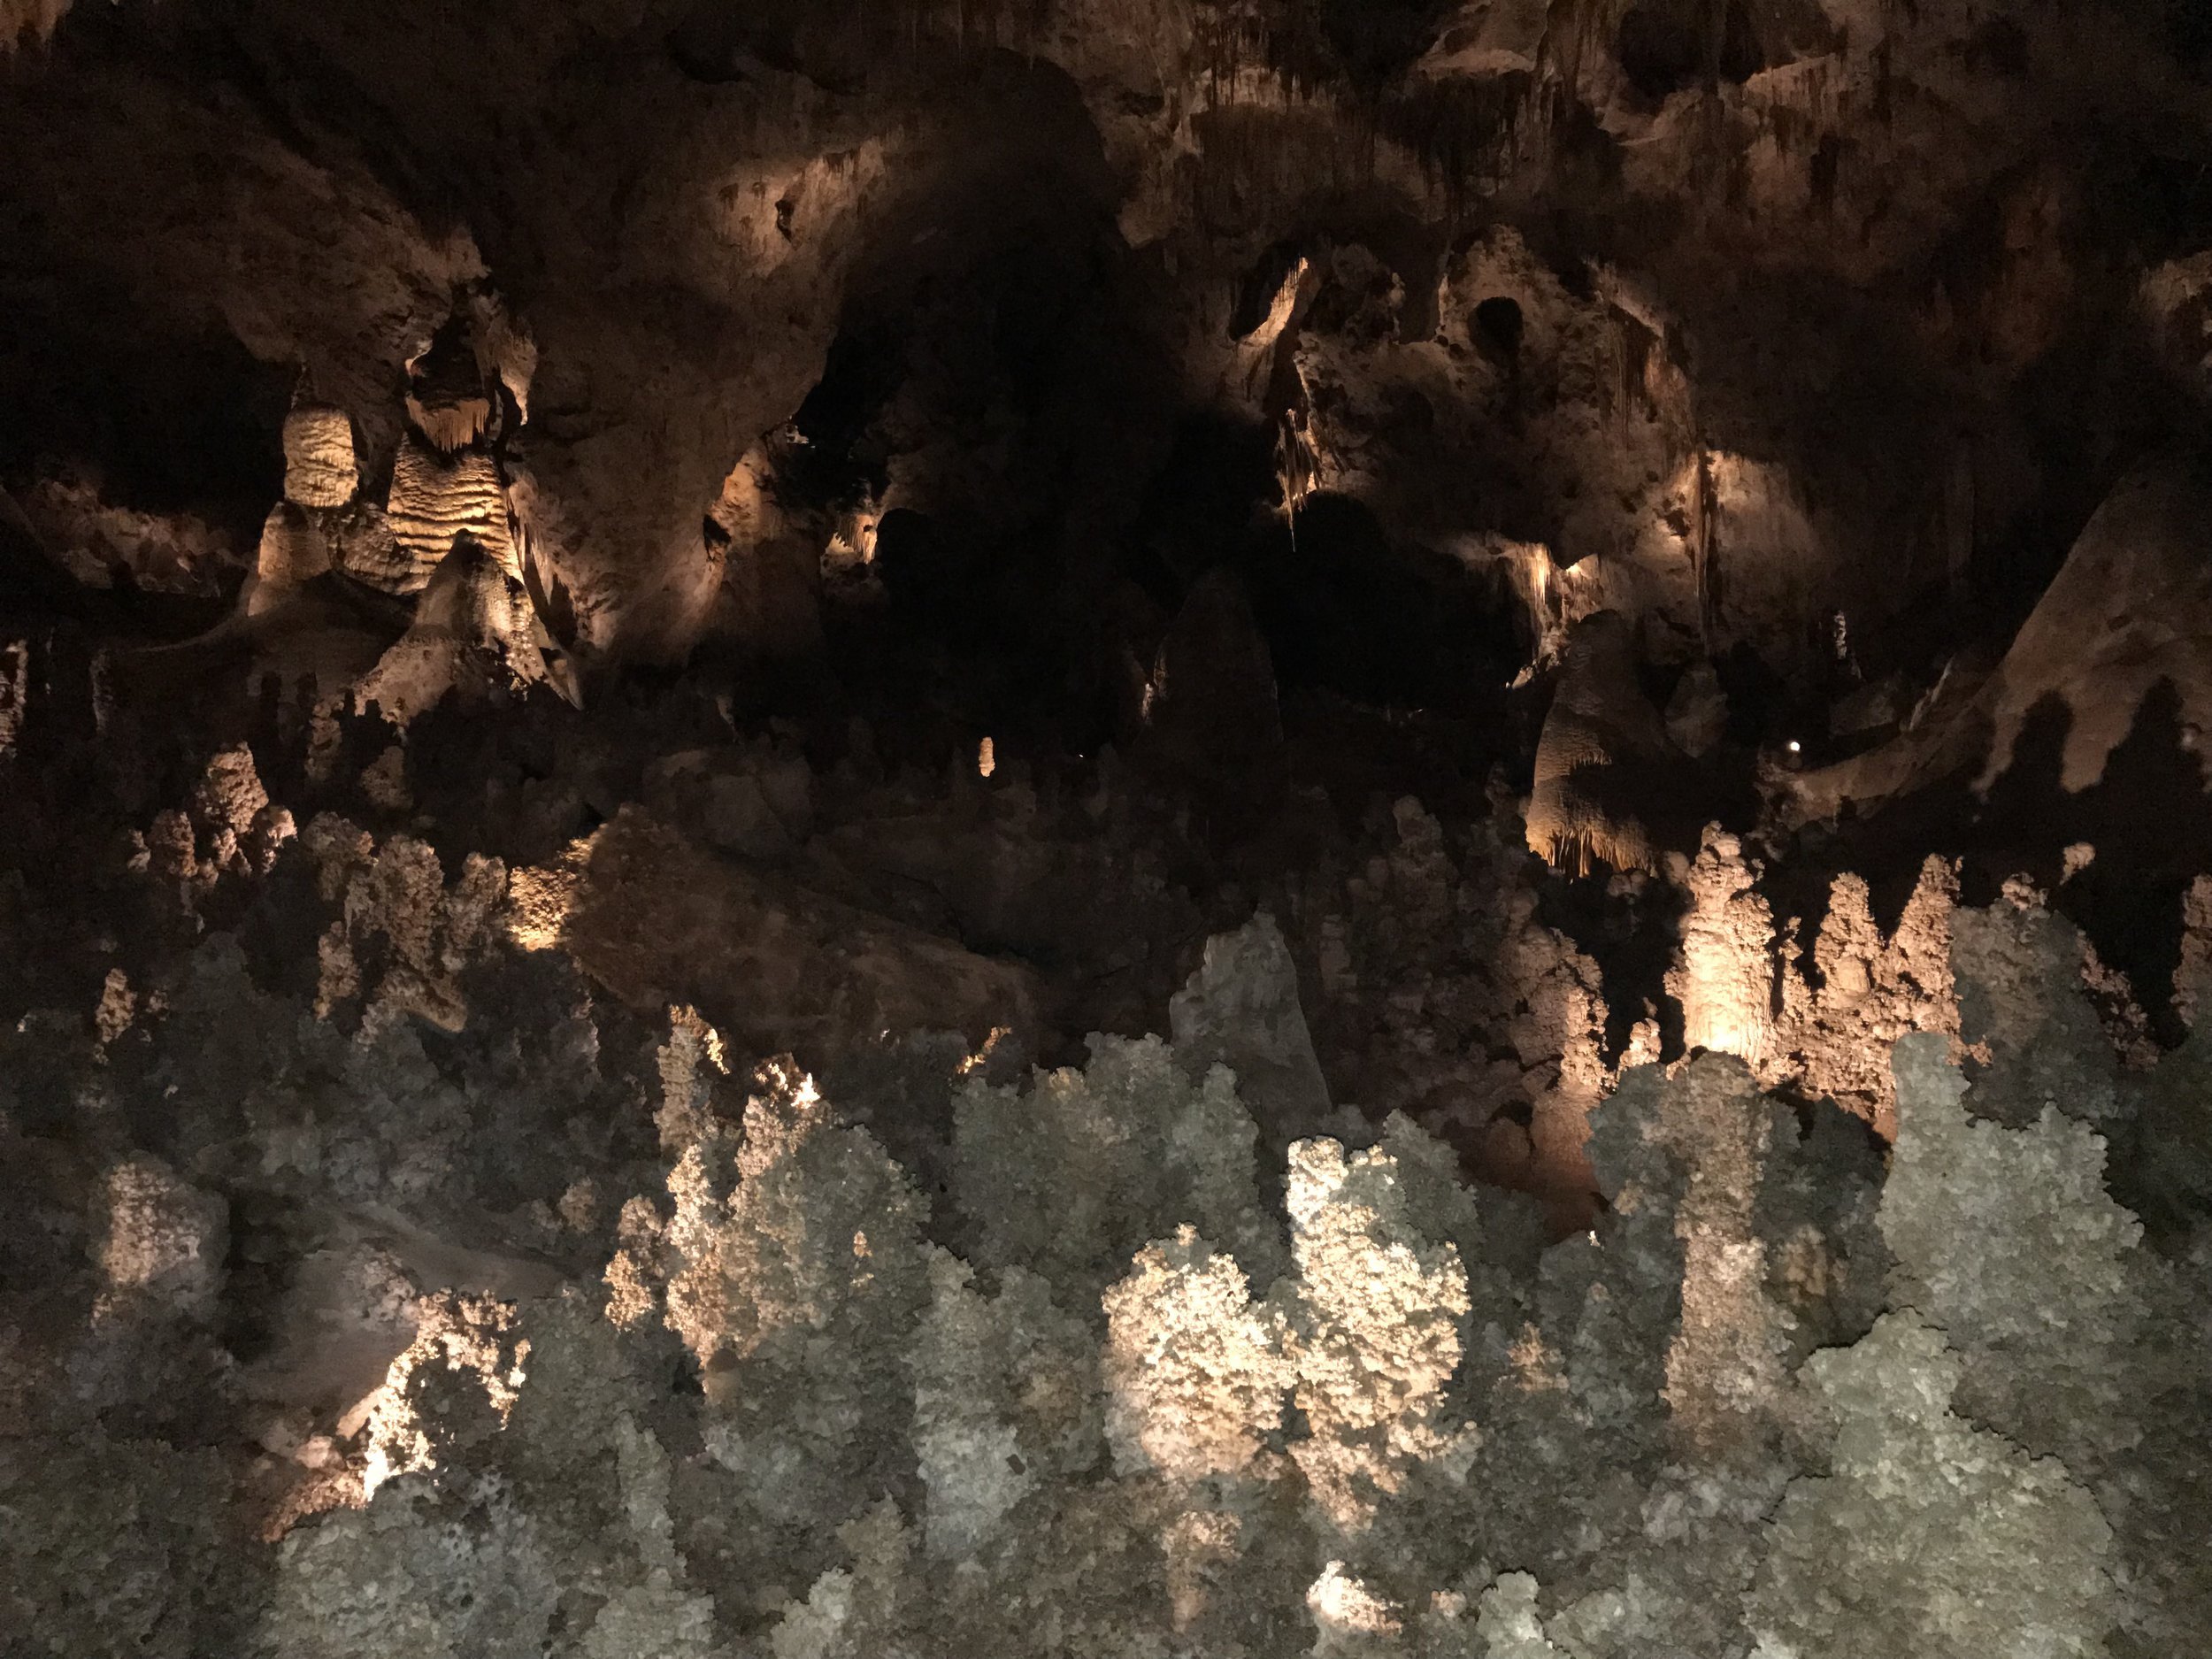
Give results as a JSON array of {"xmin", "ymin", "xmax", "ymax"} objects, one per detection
[{"xmin": 0, "ymin": 0, "xmax": 2212, "ymax": 672}]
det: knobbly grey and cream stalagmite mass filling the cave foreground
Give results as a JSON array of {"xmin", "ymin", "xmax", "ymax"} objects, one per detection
[{"xmin": 0, "ymin": 755, "xmax": 2212, "ymax": 1659}]
